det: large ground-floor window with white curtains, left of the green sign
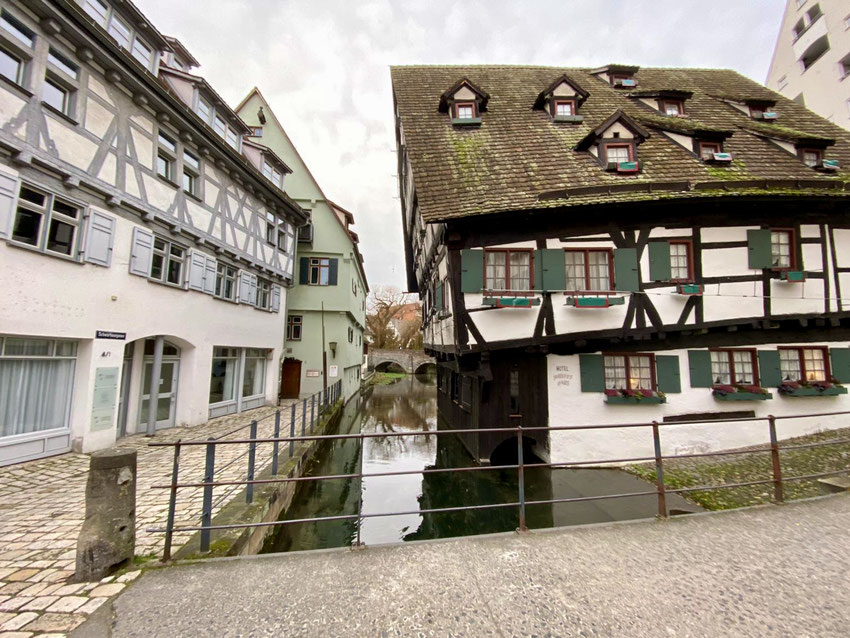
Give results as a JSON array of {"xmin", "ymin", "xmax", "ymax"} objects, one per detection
[{"xmin": 0, "ymin": 337, "xmax": 77, "ymax": 437}]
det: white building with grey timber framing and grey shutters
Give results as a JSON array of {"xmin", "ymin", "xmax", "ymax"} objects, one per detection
[{"xmin": 0, "ymin": 0, "xmax": 308, "ymax": 464}]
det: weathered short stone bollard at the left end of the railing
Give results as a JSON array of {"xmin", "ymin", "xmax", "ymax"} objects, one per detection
[{"xmin": 74, "ymin": 448, "xmax": 136, "ymax": 582}]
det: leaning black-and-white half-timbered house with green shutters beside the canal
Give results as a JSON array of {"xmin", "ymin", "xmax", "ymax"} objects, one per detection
[{"xmin": 392, "ymin": 65, "xmax": 850, "ymax": 461}]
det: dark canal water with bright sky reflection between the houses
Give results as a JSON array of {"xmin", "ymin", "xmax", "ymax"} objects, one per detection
[{"xmin": 262, "ymin": 376, "xmax": 698, "ymax": 553}]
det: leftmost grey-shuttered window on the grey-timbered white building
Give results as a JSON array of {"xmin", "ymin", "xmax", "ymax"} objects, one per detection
[{"xmin": 12, "ymin": 185, "xmax": 82, "ymax": 257}]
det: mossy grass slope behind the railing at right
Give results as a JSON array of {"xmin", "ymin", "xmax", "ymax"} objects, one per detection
[{"xmin": 624, "ymin": 428, "xmax": 850, "ymax": 510}]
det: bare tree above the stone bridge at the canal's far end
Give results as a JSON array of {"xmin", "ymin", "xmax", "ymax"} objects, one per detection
[{"xmin": 366, "ymin": 286, "xmax": 422, "ymax": 349}]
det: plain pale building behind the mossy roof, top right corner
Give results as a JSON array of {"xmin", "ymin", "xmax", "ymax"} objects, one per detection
[{"xmin": 767, "ymin": 0, "xmax": 850, "ymax": 129}]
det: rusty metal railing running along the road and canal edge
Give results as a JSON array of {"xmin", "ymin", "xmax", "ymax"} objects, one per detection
[{"xmin": 147, "ymin": 411, "xmax": 850, "ymax": 561}]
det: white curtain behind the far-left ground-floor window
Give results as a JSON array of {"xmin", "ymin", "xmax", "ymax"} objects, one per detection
[{"xmin": 0, "ymin": 359, "xmax": 75, "ymax": 436}]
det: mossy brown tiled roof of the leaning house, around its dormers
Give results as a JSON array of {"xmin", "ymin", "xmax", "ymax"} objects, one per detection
[{"xmin": 391, "ymin": 66, "xmax": 850, "ymax": 222}]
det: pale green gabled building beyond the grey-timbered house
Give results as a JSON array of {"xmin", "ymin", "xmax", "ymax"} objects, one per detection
[{"xmin": 236, "ymin": 88, "xmax": 369, "ymax": 399}]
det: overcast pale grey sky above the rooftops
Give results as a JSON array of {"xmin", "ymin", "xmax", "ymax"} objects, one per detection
[{"xmin": 136, "ymin": 0, "xmax": 785, "ymax": 289}]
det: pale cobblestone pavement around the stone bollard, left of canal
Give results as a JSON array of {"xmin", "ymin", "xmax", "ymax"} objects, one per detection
[{"xmin": 0, "ymin": 400, "xmax": 322, "ymax": 638}]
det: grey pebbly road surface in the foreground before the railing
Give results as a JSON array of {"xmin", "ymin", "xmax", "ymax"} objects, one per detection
[{"xmin": 79, "ymin": 495, "xmax": 850, "ymax": 638}]
